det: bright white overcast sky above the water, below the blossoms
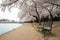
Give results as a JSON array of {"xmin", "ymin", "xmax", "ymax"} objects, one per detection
[{"xmin": 0, "ymin": 7, "xmax": 19, "ymax": 20}]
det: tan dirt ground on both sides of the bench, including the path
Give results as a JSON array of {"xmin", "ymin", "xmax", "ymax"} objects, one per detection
[{"xmin": 0, "ymin": 21, "xmax": 60, "ymax": 40}]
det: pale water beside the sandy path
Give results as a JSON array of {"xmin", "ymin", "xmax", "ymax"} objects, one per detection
[{"xmin": 0, "ymin": 23, "xmax": 22, "ymax": 35}]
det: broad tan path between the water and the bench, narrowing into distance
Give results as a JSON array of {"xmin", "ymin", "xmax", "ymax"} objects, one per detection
[{"xmin": 0, "ymin": 23, "xmax": 43, "ymax": 40}]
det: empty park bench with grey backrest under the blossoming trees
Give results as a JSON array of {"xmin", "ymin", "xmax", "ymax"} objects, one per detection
[{"xmin": 38, "ymin": 21, "xmax": 53, "ymax": 33}]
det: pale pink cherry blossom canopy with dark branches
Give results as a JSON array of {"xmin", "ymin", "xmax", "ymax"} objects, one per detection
[{"xmin": 0, "ymin": 0, "xmax": 60, "ymax": 23}]
